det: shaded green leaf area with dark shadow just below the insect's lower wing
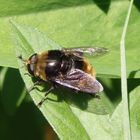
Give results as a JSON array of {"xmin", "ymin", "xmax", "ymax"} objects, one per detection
[{"xmin": 60, "ymin": 89, "xmax": 114, "ymax": 115}]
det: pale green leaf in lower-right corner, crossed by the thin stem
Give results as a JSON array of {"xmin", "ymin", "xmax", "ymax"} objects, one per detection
[{"xmin": 111, "ymin": 86, "xmax": 140, "ymax": 140}]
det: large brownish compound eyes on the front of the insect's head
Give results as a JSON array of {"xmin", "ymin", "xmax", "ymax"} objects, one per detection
[{"xmin": 27, "ymin": 53, "xmax": 37, "ymax": 76}]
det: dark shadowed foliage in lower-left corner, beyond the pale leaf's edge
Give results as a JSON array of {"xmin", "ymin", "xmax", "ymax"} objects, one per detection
[{"xmin": 0, "ymin": 67, "xmax": 57, "ymax": 140}]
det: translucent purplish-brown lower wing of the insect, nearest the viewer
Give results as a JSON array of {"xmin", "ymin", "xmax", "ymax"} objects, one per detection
[{"xmin": 55, "ymin": 69, "xmax": 103, "ymax": 94}]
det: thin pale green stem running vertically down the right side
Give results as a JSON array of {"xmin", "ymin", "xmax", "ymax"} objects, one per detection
[{"xmin": 120, "ymin": 0, "xmax": 134, "ymax": 140}]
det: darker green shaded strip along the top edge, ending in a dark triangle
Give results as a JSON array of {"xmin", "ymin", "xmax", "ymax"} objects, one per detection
[{"xmin": 0, "ymin": 0, "xmax": 111, "ymax": 17}]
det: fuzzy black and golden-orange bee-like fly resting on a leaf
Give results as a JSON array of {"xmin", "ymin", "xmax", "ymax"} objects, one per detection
[{"xmin": 19, "ymin": 48, "xmax": 107, "ymax": 105}]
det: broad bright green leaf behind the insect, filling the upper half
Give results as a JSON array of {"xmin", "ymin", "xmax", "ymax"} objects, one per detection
[{"xmin": 0, "ymin": 0, "xmax": 140, "ymax": 78}]
